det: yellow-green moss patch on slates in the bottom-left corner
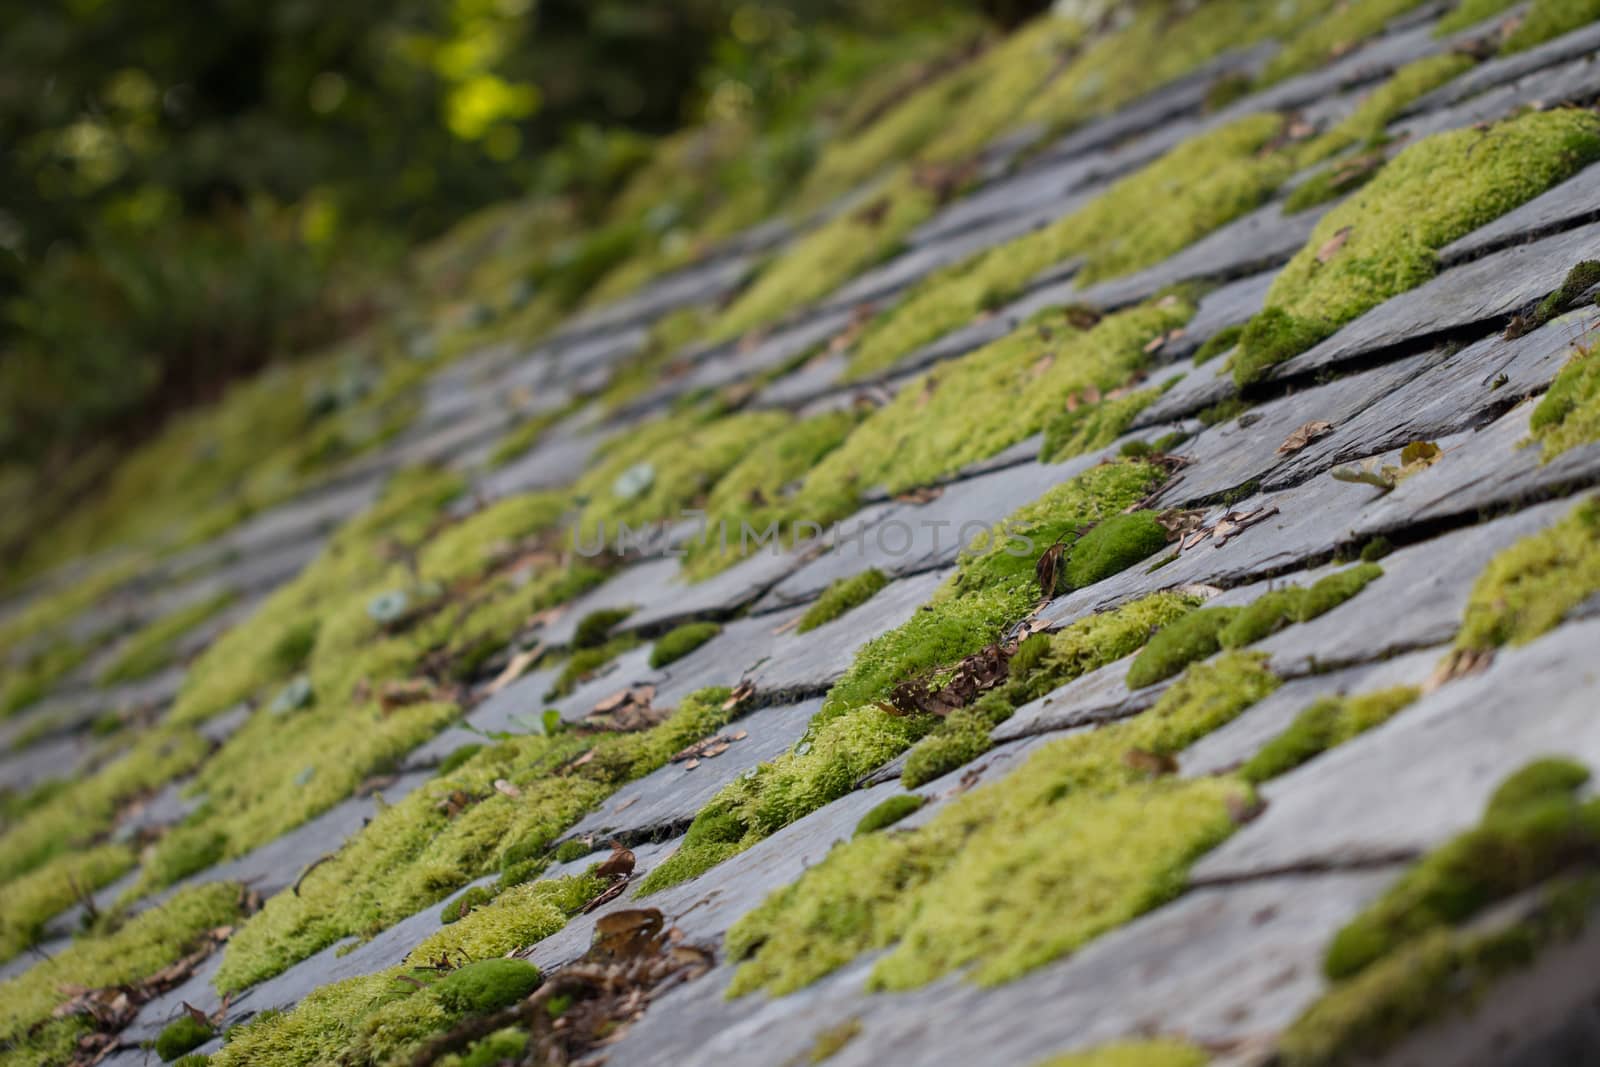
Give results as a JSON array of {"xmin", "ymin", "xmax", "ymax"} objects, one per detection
[{"xmin": 0, "ymin": 883, "xmax": 240, "ymax": 1062}]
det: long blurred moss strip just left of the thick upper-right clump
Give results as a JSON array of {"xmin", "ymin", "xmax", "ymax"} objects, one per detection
[{"xmin": 850, "ymin": 115, "xmax": 1293, "ymax": 379}]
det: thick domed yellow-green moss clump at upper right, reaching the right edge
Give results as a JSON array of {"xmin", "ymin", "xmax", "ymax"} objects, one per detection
[{"xmin": 1234, "ymin": 110, "xmax": 1600, "ymax": 386}]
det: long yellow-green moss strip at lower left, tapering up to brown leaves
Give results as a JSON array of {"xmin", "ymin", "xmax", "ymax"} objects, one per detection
[{"xmin": 216, "ymin": 689, "xmax": 731, "ymax": 990}]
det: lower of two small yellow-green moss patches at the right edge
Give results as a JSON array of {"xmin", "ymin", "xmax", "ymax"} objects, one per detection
[{"xmin": 1456, "ymin": 498, "xmax": 1600, "ymax": 651}]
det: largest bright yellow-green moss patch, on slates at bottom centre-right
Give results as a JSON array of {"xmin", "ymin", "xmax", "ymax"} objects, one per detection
[{"xmin": 725, "ymin": 654, "xmax": 1277, "ymax": 995}]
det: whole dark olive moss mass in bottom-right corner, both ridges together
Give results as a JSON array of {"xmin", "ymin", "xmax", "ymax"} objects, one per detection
[{"xmin": 1280, "ymin": 760, "xmax": 1600, "ymax": 1067}]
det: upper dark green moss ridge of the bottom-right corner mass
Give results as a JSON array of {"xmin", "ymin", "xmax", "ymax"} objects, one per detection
[{"xmin": 1323, "ymin": 763, "xmax": 1600, "ymax": 981}]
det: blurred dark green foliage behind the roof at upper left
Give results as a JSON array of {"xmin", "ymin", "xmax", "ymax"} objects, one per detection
[{"xmin": 0, "ymin": 0, "xmax": 998, "ymax": 466}]
